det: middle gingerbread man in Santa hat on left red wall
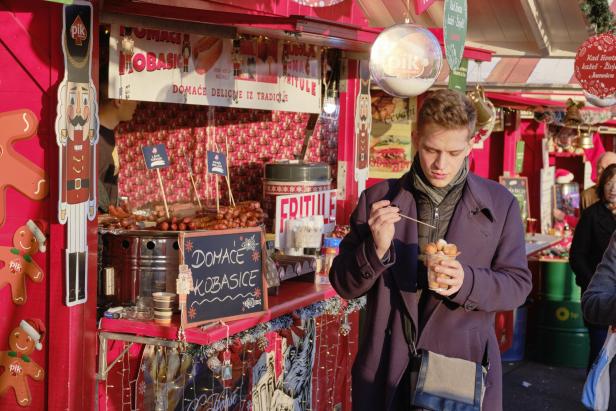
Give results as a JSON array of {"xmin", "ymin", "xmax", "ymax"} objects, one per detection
[{"xmin": 0, "ymin": 220, "xmax": 46, "ymax": 305}]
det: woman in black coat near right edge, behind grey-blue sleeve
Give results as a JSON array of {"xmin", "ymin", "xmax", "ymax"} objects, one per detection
[{"xmin": 569, "ymin": 164, "xmax": 616, "ymax": 370}]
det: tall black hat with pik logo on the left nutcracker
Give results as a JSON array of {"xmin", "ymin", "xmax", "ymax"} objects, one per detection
[{"xmin": 62, "ymin": 4, "xmax": 92, "ymax": 83}]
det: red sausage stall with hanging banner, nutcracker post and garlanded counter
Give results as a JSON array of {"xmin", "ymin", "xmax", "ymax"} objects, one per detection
[{"xmin": 0, "ymin": 1, "xmax": 374, "ymax": 409}]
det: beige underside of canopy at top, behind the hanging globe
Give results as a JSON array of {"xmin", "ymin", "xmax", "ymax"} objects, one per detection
[{"xmin": 358, "ymin": 0, "xmax": 596, "ymax": 57}]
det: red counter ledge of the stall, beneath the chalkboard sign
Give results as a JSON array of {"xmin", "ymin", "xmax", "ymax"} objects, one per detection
[{"xmin": 99, "ymin": 281, "xmax": 337, "ymax": 345}]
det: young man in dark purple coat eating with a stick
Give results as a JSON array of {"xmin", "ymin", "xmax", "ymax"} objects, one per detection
[{"xmin": 330, "ymin": 90, "xmax": 532, "ymax": 411}]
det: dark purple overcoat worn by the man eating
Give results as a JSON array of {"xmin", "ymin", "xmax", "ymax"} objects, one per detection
[{"xmin": 330, "ymin": 173, "xmax": 532, "ymax": 411}]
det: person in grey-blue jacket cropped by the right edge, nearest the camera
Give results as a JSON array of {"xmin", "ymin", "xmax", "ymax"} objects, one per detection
[{"xmin": 582, "ymin": 232, "xmax": 616, "ymax": 410}]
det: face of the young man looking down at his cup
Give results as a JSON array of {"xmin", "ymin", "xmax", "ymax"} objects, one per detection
[{"xmin": 413, "ymin": 124, "xmax": 471, "ymax": 187}]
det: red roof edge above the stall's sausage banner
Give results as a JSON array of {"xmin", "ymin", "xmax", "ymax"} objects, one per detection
[{"xmin": 103, "ymin": 0, "xmax": 492, "ymax": 61}]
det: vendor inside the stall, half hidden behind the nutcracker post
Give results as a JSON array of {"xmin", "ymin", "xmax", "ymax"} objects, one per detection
[{"xmin": 97, "ymin": 72, "xmax": 137, "ymax": 213}]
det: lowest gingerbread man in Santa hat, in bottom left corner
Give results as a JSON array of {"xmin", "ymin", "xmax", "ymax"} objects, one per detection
[{"xmin": 0, "ymin": 318, "xmax": 45, "ymax": 407}]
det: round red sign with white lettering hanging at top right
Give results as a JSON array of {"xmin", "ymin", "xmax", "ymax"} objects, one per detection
[{"xmin": 575, "ymin": 33, "xmax": 616, "ymax": 98}]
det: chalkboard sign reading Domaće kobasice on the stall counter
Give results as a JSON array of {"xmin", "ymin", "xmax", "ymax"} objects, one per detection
[{"xmin": 180, "ymin": 228, "xmax": 267, "ymax": 328}]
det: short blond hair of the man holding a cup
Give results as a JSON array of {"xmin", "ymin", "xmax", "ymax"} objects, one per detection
[{"xmin": 417, "ymin": 89, "xmax": 477, "ymax": 140}]
